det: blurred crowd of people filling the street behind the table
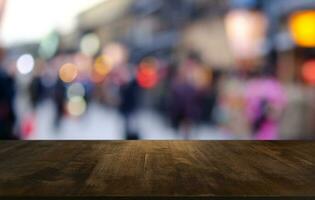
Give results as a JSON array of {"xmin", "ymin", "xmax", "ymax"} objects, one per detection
[{"xmin": 0, "ymin": 44, "xmax": 298, "ymax": 139}]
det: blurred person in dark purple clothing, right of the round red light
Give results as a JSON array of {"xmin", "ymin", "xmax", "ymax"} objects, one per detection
[{"xmin": 170, "ymin": 52, "xmax": 205, "ymax": 139}]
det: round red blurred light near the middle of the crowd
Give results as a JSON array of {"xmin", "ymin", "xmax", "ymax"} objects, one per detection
[{"xmin": 137, "ymin": 58, "xmax": 158, "ymax": 89}]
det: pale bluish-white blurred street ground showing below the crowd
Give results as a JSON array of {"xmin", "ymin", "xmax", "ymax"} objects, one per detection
[{"xmin": 27, "ymin": 101, "xmax": 232, "ymax": 140}]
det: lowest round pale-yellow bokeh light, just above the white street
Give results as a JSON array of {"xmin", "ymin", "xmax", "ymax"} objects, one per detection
[{"xmin": 67, "ymin": 96, "xmax": 86, "ymax": 117}]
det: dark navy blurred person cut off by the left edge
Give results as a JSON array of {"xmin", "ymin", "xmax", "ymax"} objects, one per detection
[{"xmin": 0, "ymin": 49, "xmax": 17, "ymax": 139}]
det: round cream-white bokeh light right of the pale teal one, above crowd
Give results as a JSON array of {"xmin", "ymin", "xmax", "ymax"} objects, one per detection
[{"xmin": 80, "ymin": 33, "xmax": 101, "ymax": 56}]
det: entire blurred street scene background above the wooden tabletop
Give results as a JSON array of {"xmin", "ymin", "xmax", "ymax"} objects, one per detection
[{"xmin": 0, "ymin": 0, "xmax": 315, "ymax": 140}]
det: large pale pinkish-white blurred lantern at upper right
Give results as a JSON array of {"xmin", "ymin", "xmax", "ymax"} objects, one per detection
[{"xmin": 225, "ymin": 10, "xmax": 267, "ymax": 59}]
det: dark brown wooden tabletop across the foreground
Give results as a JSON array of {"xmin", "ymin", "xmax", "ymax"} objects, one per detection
[{"xmin": 0, "ymin": 141, "xmax": 315, "ymax": 199}]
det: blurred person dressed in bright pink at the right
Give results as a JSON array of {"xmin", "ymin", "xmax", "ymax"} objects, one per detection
[{"xmin": 245, "ymin": 77, "xmax": 287, "ymax": 140}]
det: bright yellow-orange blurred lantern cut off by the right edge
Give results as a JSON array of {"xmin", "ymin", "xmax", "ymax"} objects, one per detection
[{"xmin": 289, "ymin": 10, "xmax": 315, "ymax": 47}]
